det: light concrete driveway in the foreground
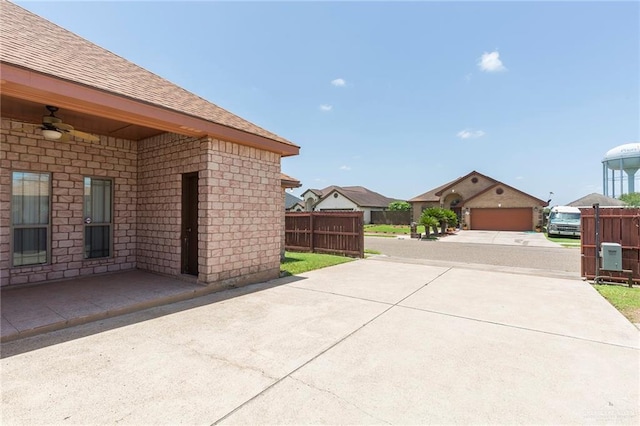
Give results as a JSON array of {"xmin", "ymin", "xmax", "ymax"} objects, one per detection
[{"xmin": 1, "ymin": 258, "xmax": 640, "ymax": 425}]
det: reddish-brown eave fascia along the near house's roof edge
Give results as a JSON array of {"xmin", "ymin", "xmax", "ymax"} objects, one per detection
[{"xmin": 0, "ymin": 62, "xmax": 300, "ymax": 157}]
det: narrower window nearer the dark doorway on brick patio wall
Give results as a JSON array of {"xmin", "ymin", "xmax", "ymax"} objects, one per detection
[{"xmin": 84, "ymin": 177, "xmax": 113, "ymax": 259}]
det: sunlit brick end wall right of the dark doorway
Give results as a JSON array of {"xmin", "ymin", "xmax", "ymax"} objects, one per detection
[{"xmin": 199, "ymin": 140, "xmax": 284, "ymax": 285}]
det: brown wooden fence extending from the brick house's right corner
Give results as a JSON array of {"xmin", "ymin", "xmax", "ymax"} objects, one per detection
[{"xmin": 284, "ymin": 212, "xmax": 364, "ymax": 257}]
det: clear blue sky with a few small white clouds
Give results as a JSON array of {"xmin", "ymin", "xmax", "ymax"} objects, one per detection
[{"xmin": 16, "ymin": 1, "xmax": 640, "ymax": 204}]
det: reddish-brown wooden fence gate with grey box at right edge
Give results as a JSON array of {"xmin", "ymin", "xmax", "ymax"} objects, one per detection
[{"xmin": 580, "ymin": 208, "xmax": 640, "ymax": 284}]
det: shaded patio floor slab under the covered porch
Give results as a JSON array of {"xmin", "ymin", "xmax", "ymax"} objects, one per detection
[{"xmin": 0, "ymin": 270, "xmax": 206, "ymax": 342}]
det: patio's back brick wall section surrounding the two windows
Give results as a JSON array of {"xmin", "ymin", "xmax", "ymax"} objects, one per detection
[{"xmin": 0, "ymin": 118, "xmax": 137, "ymax": 286}]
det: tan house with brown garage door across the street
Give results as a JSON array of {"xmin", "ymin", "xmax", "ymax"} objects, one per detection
[{"xmin": 409, "ymin": 171, "xmax": 548, "ymax": 231}]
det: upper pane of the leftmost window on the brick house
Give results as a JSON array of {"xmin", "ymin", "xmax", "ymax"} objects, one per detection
[{"xmin": 11, "ymin": 172, "xmax": 50, "ymax": 225}]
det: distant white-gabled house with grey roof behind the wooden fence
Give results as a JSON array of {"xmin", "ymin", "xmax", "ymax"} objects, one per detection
[{"xmin": 302, "ymin": 185, "xmax": 397, "ymax": 224}]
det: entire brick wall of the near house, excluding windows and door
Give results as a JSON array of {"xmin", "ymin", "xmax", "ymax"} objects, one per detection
[{"xmin": 0, "ymin": 119, "xmax": 284, "ymax": 286}]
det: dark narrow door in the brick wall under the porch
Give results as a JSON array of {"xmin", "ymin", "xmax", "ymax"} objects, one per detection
[{"xmin": 181, "ymin": 173, "xmax": 198, "ymax": 275}]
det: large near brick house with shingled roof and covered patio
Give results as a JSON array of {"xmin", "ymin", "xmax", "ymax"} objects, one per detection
[{"xmin": 0, "ymin": 0, "xmax": 299, "ymax": 287}]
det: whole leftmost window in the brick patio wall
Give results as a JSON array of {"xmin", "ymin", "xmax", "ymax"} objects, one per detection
[{"xmin": 11, "ymin": 172, "xmax": 51, "ymax": 266}]
